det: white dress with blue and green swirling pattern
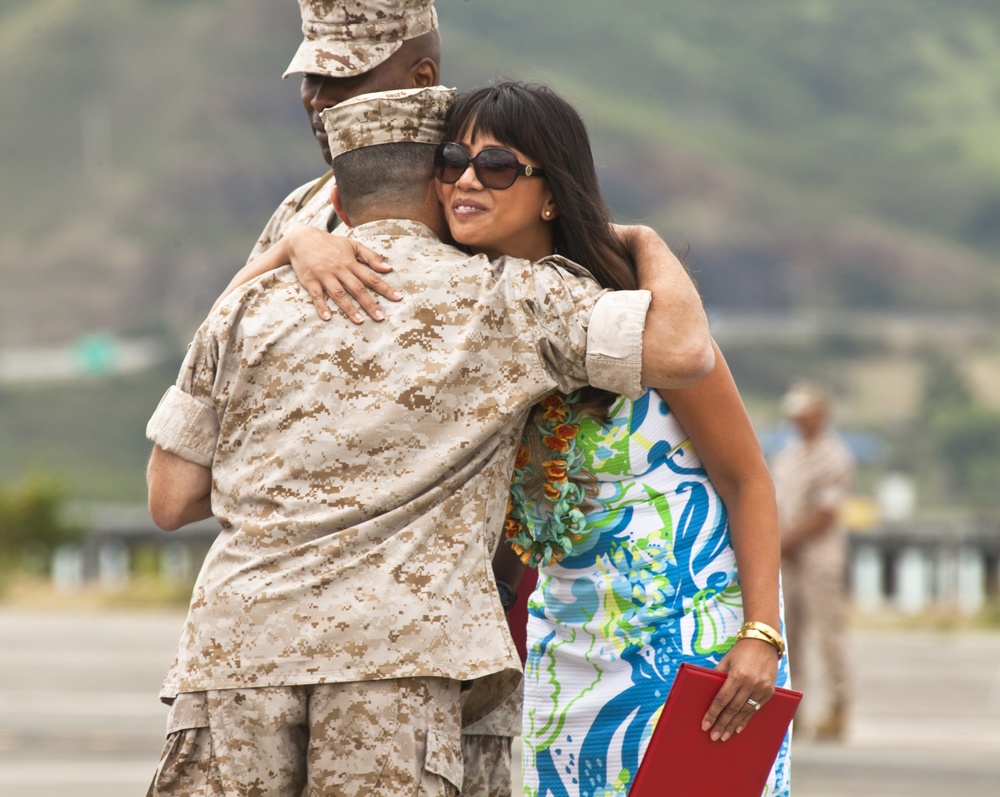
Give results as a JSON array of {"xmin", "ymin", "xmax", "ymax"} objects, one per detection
[{"xmin": 515, "ymin": 390, "xmax": 790, "ymax": 797}]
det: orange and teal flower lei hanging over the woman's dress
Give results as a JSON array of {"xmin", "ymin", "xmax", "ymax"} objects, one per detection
[{"xmin": 504, "ymin": 393, "xmax": 586, "ymax": 567}]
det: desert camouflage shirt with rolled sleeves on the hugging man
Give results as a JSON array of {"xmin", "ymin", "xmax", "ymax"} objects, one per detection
[{"xmin": 147, "ymin": 221, "xmax": 649, "ymax": 721}]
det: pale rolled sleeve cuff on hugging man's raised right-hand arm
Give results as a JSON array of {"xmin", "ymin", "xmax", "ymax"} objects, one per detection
[{"xmin": 587, "ymin": 291, "xmax": 651, "ymax": 399}]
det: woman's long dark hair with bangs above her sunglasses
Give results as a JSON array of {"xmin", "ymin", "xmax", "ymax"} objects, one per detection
[{"xmin": 445, "ymin": 81, "xmax": 638, "ymax": 290}]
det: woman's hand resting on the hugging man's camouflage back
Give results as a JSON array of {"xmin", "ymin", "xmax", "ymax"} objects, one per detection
[{"xmin": 287, "ymin": 227, "xmax": 403, "ymax": 324}]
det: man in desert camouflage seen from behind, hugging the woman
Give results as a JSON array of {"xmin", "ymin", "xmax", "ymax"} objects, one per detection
[{"xmin": 147, "ymin": 87, "xmax": 711, "ymax": 795}]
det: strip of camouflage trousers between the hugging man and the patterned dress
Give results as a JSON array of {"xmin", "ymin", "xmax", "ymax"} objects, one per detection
[{"xmin": 462, "ymin": 689, "xmax": 522, "ymax": 797}]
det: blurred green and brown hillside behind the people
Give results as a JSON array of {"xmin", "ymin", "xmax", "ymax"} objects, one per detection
[{"xmin": 0, "ymin": 0, "xmax": 1000, "ymax": 511}]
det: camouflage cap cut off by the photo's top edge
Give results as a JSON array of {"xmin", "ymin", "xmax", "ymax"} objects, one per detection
[{"xmin": 283, "ymin": 0, "xmax": 437, "ymax": 78}]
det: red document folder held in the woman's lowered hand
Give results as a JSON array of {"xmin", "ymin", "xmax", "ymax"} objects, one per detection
[{"xmin": 629, "ymin": 663, "xmax": 802, "ymax": 797}]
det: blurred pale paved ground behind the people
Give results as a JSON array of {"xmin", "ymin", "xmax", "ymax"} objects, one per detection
[{"xmin": 0, "ymin": 608, "xmax": 1000, "ymax": 797}]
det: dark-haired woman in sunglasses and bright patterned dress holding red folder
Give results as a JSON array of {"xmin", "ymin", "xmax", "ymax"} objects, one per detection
[{"xmin": 435, "ymin": 83, "xmax": 789, "ymax": 797}]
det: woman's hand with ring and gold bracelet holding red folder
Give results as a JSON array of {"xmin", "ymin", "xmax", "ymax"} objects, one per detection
[{"xmin": 701, "ymin": 639, "xmax": 778, "ymax": 742}]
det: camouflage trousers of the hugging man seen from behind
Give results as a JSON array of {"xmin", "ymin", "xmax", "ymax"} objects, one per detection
[{"xmin": 147, "ymin": 678, "xmax": 462, "ymax": 797}]
